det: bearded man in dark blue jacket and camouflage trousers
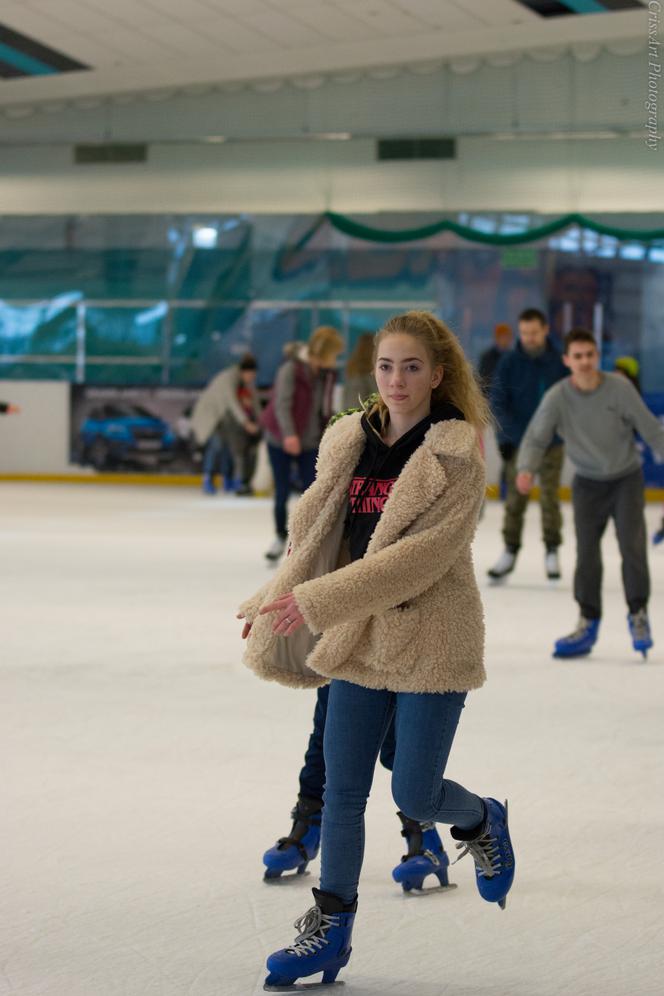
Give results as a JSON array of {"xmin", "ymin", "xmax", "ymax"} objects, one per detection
[{"xmin": 488, "ymin": 308, "xmax": 567, "ymax": 581}]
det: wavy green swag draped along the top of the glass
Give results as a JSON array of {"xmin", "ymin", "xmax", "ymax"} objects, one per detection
[{"xmin": 322, "ymin": 211, "xmax": 664, "ymax": 246}]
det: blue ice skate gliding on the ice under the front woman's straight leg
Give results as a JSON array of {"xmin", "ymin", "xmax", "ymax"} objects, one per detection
[{"xmin": 263, "ymin": 889, "xmax": 357, "ymax": 992}]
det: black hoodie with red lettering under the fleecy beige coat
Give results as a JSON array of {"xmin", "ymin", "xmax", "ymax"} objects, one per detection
[{"xmin": 344, "ymin": 401, "xmax": 464, "ymax": 561}]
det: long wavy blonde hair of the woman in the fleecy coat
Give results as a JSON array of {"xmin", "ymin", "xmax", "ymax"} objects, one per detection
[{"xmin": 367, "ymin": 311, "xmax": 492, "ymax": 431}]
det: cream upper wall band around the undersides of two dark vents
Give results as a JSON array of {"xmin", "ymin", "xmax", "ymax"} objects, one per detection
[{"xmin": 0, "ymin": 138, "xmax": 652, "ymax": 216}]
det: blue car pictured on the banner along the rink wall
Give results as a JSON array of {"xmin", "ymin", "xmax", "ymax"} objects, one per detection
[{"xmin": 79, "ymin": 402, "xmax": 176, "ymax": 470}]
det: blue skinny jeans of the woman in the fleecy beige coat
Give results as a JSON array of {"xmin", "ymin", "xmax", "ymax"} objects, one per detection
[{"xmin": 320, "ymin": 681, "xmax": 484, "ymax": 903}]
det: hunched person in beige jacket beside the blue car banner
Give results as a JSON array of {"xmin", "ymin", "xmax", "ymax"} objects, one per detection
[{"xmin": 191, "ymin": 353, "xmax": 260, "ymax": 495}]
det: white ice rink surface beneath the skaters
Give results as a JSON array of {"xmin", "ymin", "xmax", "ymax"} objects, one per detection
[{"xmin": 0, "ymin": 484, "xmax": 664, "ymax": 996}]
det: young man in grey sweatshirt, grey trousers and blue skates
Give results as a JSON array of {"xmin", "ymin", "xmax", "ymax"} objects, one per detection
[{"xmin": 516, "ymin": 329, "xmax": 664, "ymax": 657}]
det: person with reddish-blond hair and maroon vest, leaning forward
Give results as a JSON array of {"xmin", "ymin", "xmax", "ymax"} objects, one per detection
[{"xmin": 261, "ymin": 325, "xmax": 344, "ymax": 561}]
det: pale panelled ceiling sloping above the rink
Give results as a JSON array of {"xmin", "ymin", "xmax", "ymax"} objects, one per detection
[{"xmin": 0, "ymin": 0, "xmax": 648, "ymax": 107}]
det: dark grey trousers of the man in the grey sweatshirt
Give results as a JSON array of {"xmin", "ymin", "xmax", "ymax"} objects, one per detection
[{"xmin": 572, "ymin": 469, "xmax": 650, "ymax": 619}]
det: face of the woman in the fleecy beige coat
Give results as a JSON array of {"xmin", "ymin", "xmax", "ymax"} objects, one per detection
[{"xmin": 375, "ymin": 333, "xmax": 443, "ymax": 418}]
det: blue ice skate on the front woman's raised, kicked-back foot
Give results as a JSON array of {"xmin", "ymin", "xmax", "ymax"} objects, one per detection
[{"xmin": 450, "ymin": 799, "xmax": 514, "ymax": 910}]
